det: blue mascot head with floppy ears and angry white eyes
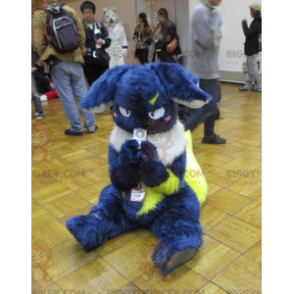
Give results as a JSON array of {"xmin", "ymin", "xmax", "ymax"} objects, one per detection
[{"xmin": 80, "ymin": 63, "xmax": 211, "ymax": 133}]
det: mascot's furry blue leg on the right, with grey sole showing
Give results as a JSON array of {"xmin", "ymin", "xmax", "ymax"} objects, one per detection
[{"xmin": 152, "ymin": 185, "xmax": 203, "ymax": 274}]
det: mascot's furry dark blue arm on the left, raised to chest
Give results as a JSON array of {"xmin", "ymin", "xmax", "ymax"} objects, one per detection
[{"xmin": 108, "ymin": 140, "xmax": 140, "ymax": 192}]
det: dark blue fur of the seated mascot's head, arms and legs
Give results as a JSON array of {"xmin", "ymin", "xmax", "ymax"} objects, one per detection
[{"xmin": 66, "ymin": 63, "xmax": 210, "ymax": 272}]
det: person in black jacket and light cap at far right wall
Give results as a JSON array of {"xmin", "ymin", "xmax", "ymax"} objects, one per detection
[{"xmin": 239, "ymin": 3, "xmax": 262, "ymax": 92}]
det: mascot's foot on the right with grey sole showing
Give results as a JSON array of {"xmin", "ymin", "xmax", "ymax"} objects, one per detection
[{"xmin": 152, "ymin": 241, "xmax": 198, "ymax": 275}]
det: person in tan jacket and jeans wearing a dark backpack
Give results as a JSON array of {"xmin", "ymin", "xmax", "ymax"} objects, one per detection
[{"xmin": 33, "ymin": 0, "xmax": 98, "ymax": 136}]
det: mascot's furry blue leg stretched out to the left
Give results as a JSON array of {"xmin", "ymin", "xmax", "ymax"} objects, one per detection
[{"xmin": 66, "ymin": 185, "xmax": 138, "ymax": 252}]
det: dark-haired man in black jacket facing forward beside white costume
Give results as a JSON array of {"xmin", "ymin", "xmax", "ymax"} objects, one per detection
[{"xmin": 80, "ymin": 1, "xmax": 111, "ymax": 86}]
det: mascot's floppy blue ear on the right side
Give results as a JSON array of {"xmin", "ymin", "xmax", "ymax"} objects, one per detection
[{"xmin": 152, "ymin": 63, "xmax": 212, "ymax": 109}]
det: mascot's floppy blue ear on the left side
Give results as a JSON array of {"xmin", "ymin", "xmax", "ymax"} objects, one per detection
[{"xmin": 80, "ymin": 65, "xmax": 131, "ymax": 113}]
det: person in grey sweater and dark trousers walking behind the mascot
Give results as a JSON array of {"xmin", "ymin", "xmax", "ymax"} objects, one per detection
[{"xmin": 184, "ymin": 0, "xmax": 227, "ymax": 144}]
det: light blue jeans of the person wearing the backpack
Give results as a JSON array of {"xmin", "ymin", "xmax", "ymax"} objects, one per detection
[{"xmin": 51, "ymin": 61, "xmax": 96, "ymax": 132}]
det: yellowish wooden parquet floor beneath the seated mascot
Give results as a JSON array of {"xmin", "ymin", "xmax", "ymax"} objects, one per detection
[{"xmin": 31, "ymin": 84, "xmax": 262, "ymax": 294}]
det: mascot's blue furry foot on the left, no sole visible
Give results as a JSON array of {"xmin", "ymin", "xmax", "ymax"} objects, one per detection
[{"xmin": 65, "ymin": 215, "xmax": 101, "ymax": 253}]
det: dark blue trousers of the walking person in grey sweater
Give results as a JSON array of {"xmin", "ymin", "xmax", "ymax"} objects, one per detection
[{"xmin": 184, "ymin": 79, "xmax": 218, "ymax": 137}]
